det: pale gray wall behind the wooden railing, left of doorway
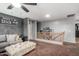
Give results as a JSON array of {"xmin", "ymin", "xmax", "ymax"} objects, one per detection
[{"xmin": 38, "ymin": 17, "xmax": 75, "ymax": 43}]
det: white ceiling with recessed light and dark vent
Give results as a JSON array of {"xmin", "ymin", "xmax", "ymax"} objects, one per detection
[{"xmin": 0, "ymin": 3, "xmax": 79, "ymax": 21}]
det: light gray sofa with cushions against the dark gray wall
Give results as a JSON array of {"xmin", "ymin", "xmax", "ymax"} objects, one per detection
[{"xmin": 0, "ymin": 34, "xmax": 22, "ymax": 52}]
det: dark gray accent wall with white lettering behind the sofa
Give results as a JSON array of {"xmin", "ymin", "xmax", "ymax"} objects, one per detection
[{"xmin": 0, "ymin": 13, "xmax": 23, "ymax": 34}]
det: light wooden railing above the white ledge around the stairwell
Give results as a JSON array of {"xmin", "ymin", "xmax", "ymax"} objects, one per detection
[{"xmin": 37, "ymin": 32, "xmax": 64, "ymax": 42}]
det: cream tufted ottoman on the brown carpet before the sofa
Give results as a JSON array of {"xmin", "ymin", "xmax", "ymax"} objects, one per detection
[{"xmin": 5, "ymin": 41, "xmax": 36, "ymax": 56}]
